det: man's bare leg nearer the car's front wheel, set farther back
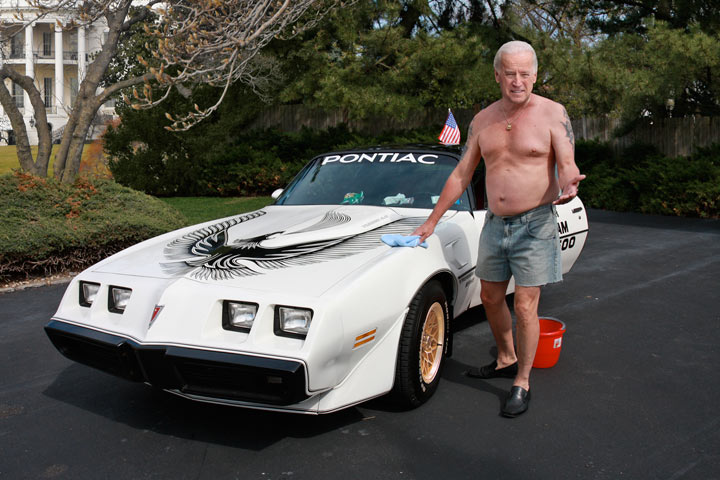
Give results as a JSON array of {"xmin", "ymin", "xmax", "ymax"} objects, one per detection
[{"xmin": 480, "ymin": 280, "xmax": 516, "ymax": 369}]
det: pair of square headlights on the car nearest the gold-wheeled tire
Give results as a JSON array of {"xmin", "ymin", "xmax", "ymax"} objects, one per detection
[{"xmin": 222, "ymin": 300, "xmax": 313, "ymax": 338}]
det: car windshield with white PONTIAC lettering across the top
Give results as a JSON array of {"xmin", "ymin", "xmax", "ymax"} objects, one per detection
[{"xmin": 276, "ymin": 151, "xmax": 471, "ymax": 210}]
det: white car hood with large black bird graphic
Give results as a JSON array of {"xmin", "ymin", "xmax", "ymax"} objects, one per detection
[{"xmin": 92, "ymin": 205, "xmax": 436, "ymax": 296}]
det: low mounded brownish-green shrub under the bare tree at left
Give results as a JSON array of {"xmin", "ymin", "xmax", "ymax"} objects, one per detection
[{"xmin": 0, "ymin": 172, "xmax": 186, "ymax": 280}]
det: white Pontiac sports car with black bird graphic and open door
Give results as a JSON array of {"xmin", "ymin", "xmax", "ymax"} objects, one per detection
[{"xmin": 45, "ymin": 147, "xmax": 588, "ymax": 413}]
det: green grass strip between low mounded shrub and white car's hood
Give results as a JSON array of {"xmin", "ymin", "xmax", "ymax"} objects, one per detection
[{"xmin": 161, "ymin": 197, "xmax": 273, "ymax": 225}]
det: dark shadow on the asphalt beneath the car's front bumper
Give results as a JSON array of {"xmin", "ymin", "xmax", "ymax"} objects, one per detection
[{"xmin": 43, "ymin": 364, "xmax": 363, "ymax": 450}]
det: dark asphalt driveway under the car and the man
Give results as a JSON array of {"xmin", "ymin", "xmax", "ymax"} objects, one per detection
[{"xmin": 0, "ymin": 211, "xmax": 720, "ymax": 480}]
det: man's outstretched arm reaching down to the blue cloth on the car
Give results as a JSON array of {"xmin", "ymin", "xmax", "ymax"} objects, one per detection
[{"xmin": 413, "ymin": 119, "xmax": 482, "ymax": 243}]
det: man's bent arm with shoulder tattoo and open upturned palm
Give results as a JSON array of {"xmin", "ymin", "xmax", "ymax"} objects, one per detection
[{"xmin": 550, "ymin": 105, "xmax": 585, "ymax": 205}]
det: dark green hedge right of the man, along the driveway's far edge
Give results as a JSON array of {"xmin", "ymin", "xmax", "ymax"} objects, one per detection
[{"xmin": 575, "ymin": 141, "xmax": 720, "ymax": 218}]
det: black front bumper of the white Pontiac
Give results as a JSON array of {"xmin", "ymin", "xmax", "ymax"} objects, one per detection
[{"xmin": 45, "ymin": 320, "xmax": 309, "ymax": 405}]
